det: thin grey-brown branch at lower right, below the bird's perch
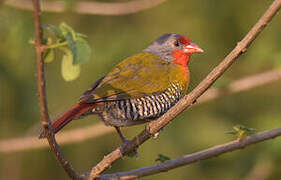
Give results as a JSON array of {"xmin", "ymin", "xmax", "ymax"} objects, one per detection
[{"xmin": 98, "ymin": 128, "xmax": 281, "ymax": 180}]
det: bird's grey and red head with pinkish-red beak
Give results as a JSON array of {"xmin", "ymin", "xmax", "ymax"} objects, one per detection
[{"xmin": 144, "ymin": 34, "xmax": 204, "ymax": 66}]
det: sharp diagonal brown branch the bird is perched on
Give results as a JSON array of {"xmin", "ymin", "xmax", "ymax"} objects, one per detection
[{"xmin": 89, "ymin": 0, "xmax": 281, "ymax": 179}]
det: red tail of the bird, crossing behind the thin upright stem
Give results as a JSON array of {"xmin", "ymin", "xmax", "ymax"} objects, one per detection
[{"xmin": 39, "ymin": 103, "xmax": 93, "ymax": 138}]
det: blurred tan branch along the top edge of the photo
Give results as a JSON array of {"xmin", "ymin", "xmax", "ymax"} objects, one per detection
[{"xmin": 4, "ymin": 0, "xmax": 166, "ymax": 15}]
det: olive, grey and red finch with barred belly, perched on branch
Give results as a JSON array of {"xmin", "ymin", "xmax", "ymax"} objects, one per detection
[{"xmin": 39, "ymin": 33, "xmax": 204, "ymax": 142}]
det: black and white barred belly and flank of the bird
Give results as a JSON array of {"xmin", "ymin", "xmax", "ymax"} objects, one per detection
[{"xmin": 99, "ymin": 83, "xmax": 184, "ymax": 126}]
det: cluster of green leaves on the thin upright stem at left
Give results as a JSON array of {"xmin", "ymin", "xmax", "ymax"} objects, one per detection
[{"xmin": 43, "ymin": 23, "xmax": 91, "ymax": 81}]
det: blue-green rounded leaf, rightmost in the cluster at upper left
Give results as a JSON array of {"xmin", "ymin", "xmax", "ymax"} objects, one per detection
[{"xmin": 73, "ymin": 38, "xmax": 91, "ymax": 65}]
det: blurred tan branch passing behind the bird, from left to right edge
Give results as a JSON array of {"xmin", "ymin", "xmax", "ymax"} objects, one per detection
[{"xmin": 0, "ymin": 69, "xmax": 281, "ymax": 153}]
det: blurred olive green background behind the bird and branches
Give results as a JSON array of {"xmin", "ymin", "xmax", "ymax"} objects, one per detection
[{"xmin": 0, "ymin": 0, "xmax": 281, "ymax": 180}]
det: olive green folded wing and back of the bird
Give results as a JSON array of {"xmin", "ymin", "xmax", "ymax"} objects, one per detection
[{"xmin": 82, "ymin": 53, "xmax": 177, "ymax": 103}]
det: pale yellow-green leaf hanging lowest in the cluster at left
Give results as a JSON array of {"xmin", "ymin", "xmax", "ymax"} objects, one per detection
[{"xmin": 61, "ymin": 48, "xmax": 80, "ymax": 81}]
